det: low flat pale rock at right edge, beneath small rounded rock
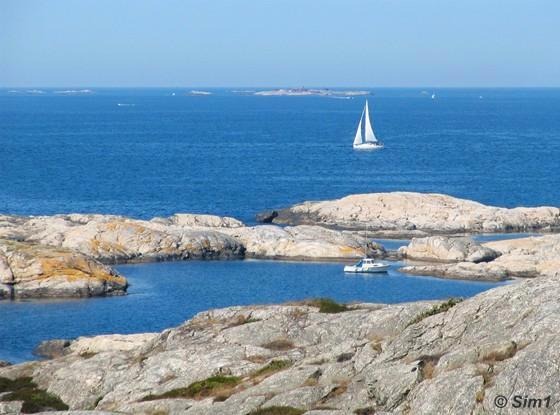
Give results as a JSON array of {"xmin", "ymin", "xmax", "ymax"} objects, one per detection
[{"xmin": 401, "ymin": 234, "xmax": 560, "ymax": 280}]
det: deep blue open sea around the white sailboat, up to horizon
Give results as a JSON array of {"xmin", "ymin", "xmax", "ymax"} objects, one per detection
[{"xmin": 0, "ymin": 89, "xmax": 560, "ymax": 222}]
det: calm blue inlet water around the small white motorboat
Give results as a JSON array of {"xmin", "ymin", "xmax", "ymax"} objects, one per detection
[{"xmin": 0, "ymin": 261, "xmax": 504, "ymax": 361}]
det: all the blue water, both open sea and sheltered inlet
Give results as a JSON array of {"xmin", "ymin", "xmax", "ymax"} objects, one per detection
[{"xmin": 0, "ymin": 88, "xmax": 560, "ymax": 361}]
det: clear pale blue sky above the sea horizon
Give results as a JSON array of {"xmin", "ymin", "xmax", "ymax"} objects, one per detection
[{"xmin": 0, "ymin": 0, "xmax": 560, "ymax": 87}]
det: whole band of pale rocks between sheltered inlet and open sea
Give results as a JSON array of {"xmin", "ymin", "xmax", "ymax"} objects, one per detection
[{"xmin": 0, "ymin": 192, "xmax": 560, "ymax": 299}]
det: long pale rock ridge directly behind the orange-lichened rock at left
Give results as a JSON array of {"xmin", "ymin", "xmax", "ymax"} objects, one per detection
[{"xmin": 0, "ymin": 214, "xmax": 244, "ymax": 263}]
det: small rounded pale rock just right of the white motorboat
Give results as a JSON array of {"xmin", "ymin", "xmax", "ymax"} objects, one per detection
[{"xmin": 399, "ymin": 236, "xmax": 500, "ymax": 263}]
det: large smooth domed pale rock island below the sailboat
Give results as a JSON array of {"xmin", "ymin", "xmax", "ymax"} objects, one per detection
[{"xmin": 264, "ymin": 192, "xmax": 560, "ymax": 237}]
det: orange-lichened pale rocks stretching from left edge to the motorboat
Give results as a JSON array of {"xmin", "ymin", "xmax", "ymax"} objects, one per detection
[{"xmin": 0, "ymin": 214, "xmax": 378, "ymax": 299}]
